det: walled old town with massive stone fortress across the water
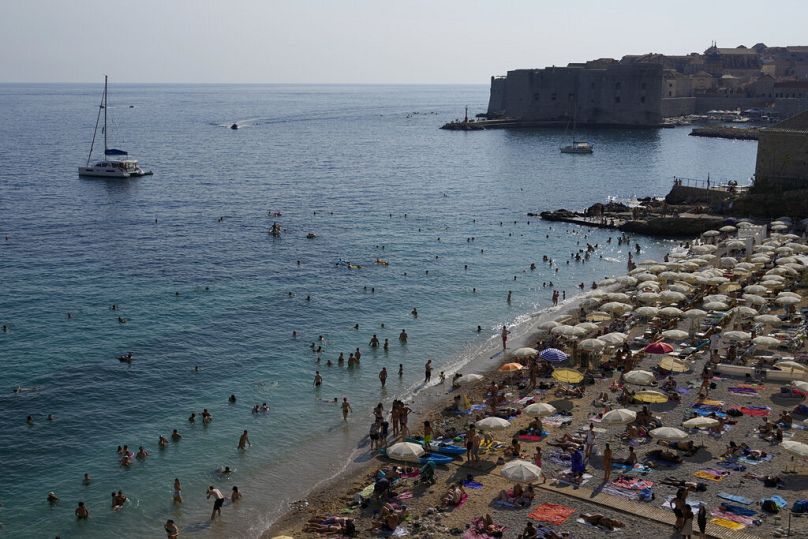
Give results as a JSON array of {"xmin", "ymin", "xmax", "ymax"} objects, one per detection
[{"xmin": 488, "ymin": 43, "xmax": 808, "ymax": 126}]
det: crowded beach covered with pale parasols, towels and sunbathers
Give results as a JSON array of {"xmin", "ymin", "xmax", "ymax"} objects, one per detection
[{"xmin": 264, "ymin": 223, "xmax": 808, "ymax": 538}]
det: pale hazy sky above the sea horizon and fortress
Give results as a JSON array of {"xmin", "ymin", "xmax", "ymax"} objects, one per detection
[{"xmin": 0, "ymin": 0, "xmax": 808, "ymax": 84}]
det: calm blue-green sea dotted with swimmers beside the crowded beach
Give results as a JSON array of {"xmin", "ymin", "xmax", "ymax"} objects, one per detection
[{"xmin": 0, "ymin": 80, "xmax": 755, "ymax": 537}]
